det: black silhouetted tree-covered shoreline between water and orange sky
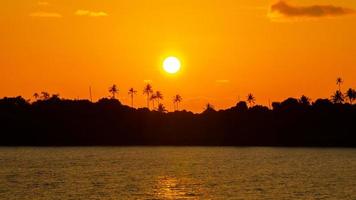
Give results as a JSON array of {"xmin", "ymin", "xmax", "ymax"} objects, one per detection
[{"xmin": 0, "ymin": 93, "xmax": 356, "ymax": 147}]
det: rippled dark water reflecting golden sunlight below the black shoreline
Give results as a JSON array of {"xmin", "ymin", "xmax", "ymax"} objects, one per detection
[{"xmin": 0, "ymin": 147, "xmax": 356, "ymax": 200}]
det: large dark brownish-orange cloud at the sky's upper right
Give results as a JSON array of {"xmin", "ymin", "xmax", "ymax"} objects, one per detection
[{"xmin": 269, "ymin": 0, "xmax": 355, "ymax": 18}]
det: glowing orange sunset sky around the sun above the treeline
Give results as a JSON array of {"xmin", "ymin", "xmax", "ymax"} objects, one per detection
[{"xmin": 0, "ymin": 0, "xmax": 356, "ymax": 112}]
